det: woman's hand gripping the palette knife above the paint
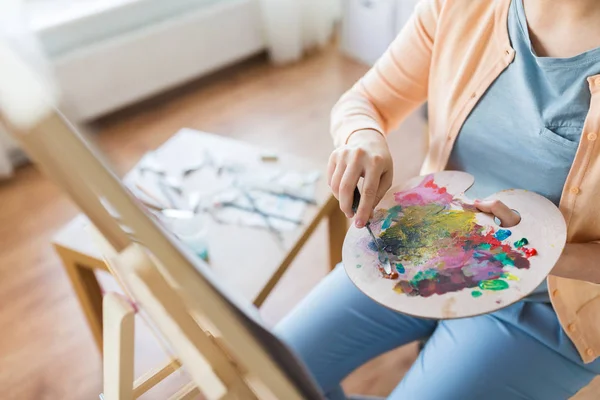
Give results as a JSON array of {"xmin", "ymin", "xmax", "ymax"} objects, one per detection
[{"xmin": 327, "ymin": 129, "xmax": 393, "ymax": 228}]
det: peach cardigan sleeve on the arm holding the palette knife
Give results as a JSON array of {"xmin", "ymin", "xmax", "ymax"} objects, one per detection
[{"xmin": 331, "ymin": 0, "xmax": 444, "ymax": 146}]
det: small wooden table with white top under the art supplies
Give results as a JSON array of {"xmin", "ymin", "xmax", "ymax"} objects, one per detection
[{"xmin": 53, "ymin": 129, "xmax": 347, "ymax": 351}]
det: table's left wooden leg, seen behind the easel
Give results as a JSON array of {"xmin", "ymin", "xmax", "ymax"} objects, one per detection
[{"xmin": 55, "ymin": 246, "xmax": 102, "ymax": 353}]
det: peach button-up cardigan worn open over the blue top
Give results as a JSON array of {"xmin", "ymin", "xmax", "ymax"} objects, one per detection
[{"xmin": 332, "ymin": 0, "xmax": 600, "ymax": 363}]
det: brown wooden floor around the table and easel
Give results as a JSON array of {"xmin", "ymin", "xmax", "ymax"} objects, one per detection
[{"xmin": 0, "ymin": 49, "xmax": 597, "ymax": 400}]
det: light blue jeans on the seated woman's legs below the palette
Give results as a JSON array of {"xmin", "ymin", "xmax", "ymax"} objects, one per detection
[{"xmin": 275, "ymin": 265, "xmax": 600, "ymax": 400}]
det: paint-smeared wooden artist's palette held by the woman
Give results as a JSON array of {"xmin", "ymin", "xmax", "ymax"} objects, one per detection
[{"xmin": 342, "ymin": 171, "xmax": 566, "ymax": 319}]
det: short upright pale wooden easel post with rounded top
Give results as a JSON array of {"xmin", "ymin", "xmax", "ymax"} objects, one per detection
[{"xmin": 104, "ymin": 293, "xmax": 135, "ymax": 400}]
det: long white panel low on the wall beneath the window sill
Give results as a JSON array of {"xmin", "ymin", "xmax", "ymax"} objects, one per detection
[{"xmin": 53, "ymin": 0, "xmax": 266, "ymax": 121}]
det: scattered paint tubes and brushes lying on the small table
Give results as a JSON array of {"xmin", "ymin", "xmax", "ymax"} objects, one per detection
[{"xmin": 126, "ymin": 137, "xmax": 320, "ymax": 252}]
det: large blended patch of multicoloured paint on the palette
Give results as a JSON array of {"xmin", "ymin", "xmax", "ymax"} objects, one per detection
[{"xmin": 367, "ymin": 175, "xmax": 535, "ymax": 297}]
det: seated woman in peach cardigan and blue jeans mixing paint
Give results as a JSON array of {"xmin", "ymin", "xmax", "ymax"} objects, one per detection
[{"xmin": 277, "ymin": 0, "xmax": 600, "ymax": 400}]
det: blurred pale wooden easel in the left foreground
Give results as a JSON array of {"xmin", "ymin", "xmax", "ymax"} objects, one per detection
[{"xmin": 4, "ymin": 112, "xmax": 323, "ymax": 400}]
